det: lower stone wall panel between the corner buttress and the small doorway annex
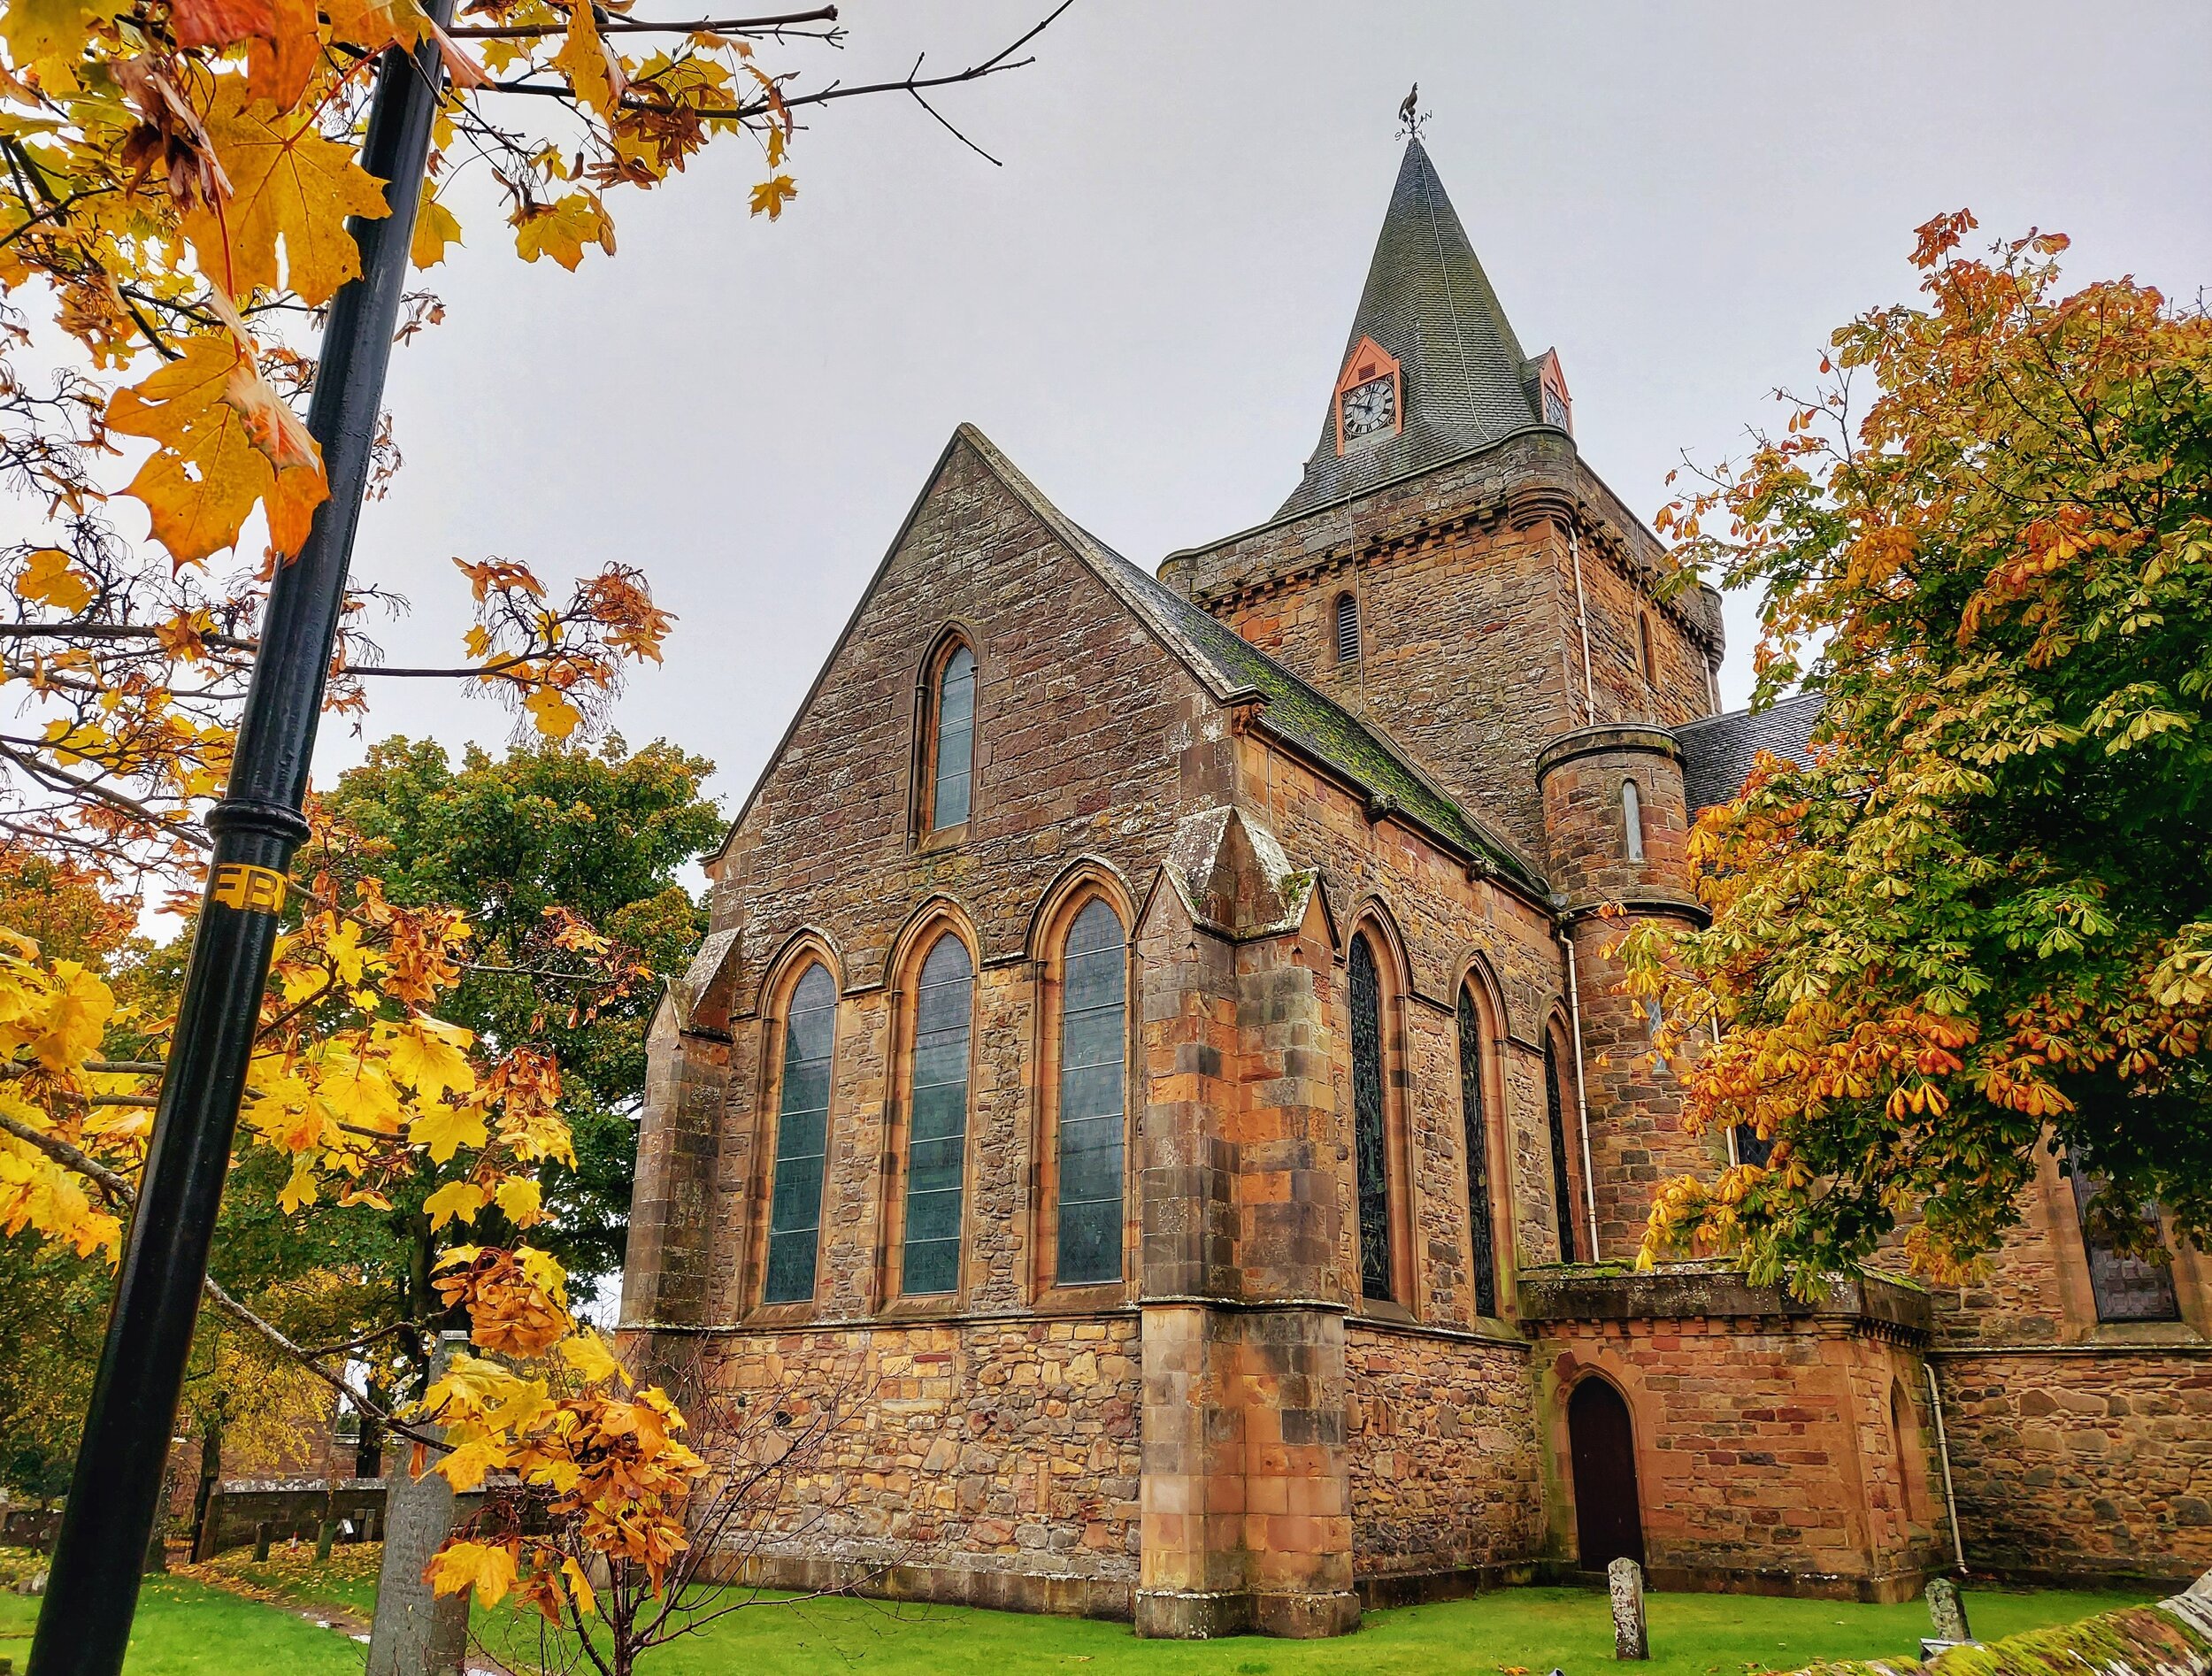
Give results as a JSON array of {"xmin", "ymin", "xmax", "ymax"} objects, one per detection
[{"xmin": 1345, "ymin": 1326, "xmax": 1544, "ymax": 1583}]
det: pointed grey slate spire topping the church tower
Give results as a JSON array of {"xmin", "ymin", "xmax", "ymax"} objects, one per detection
[{"xmin": 1277, "ymin": 137, "xmax": 1540, "ymax": 518}]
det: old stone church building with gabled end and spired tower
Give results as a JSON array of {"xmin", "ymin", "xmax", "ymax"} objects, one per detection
[{"xmin": 624, "ymin": 139, "xmax": 2212, "ymax": 1636}]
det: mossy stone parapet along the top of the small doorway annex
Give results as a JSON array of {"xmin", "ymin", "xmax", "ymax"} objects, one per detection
[{"xmin": 1520, "ymin": 1263, "xmax": 1933, "ymax": 1340}]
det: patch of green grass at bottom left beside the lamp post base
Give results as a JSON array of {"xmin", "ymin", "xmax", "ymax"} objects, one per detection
[{"xmin": 0, "ymin": 1577, "xmax": 363, "ymax": 1676}]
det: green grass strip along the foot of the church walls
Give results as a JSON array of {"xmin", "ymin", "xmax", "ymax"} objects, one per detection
[{"xmin": 475, "ymin": 1588, "xmax": 2146, "ymax": 1676}]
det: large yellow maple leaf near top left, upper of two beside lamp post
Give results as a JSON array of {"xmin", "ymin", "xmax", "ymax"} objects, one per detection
[{"xmin": 184, "ymin": 75, "xmax": 392, "ymax": 305}]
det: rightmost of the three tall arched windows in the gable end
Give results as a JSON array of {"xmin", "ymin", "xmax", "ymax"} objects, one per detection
[{"xmin": 1053, "ymin": 900, "xmax": 1128, "ymax": 1287}]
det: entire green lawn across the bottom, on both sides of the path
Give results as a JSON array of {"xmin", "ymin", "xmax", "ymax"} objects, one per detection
[{"xmin": 0, "ymin": 1550, "xmax": 2146, "ymax": 1676}]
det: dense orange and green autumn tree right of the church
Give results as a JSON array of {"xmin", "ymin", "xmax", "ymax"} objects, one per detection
[{"xmin": 1622, "ymin": 212, "xmax": 2212, "ymax": 1285}]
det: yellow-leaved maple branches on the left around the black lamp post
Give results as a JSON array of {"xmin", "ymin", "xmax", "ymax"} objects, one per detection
[{"xmin": 0, "ymin": 0, "xmax": 1062, "ymax": 1658}]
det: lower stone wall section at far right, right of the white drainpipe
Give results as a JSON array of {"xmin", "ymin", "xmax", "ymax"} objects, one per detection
[{"xmin": 1933, "ymin": 1344, "xmax": 2212, "ymax": 1583}]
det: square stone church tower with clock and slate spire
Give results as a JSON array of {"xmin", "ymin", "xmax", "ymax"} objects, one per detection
[{"xmin": 1159, "ymin": 135, "xmax": 1724, "ymax": 869}]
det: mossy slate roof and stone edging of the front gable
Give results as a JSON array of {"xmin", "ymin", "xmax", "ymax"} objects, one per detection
[{"xmin": 717, "ymin": 422, "xmax": 1542, "ymax": 891}]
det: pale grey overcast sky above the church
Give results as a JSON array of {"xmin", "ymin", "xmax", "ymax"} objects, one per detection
[{"xmin": 332, "ymin": 0, "xmax": 2212, "ymax": 826}]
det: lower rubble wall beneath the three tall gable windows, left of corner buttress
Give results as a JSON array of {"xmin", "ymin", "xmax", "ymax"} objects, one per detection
[{"xmin": 695, "ymin": 1311, "xmax": 1144, "ymax": 1617}]
